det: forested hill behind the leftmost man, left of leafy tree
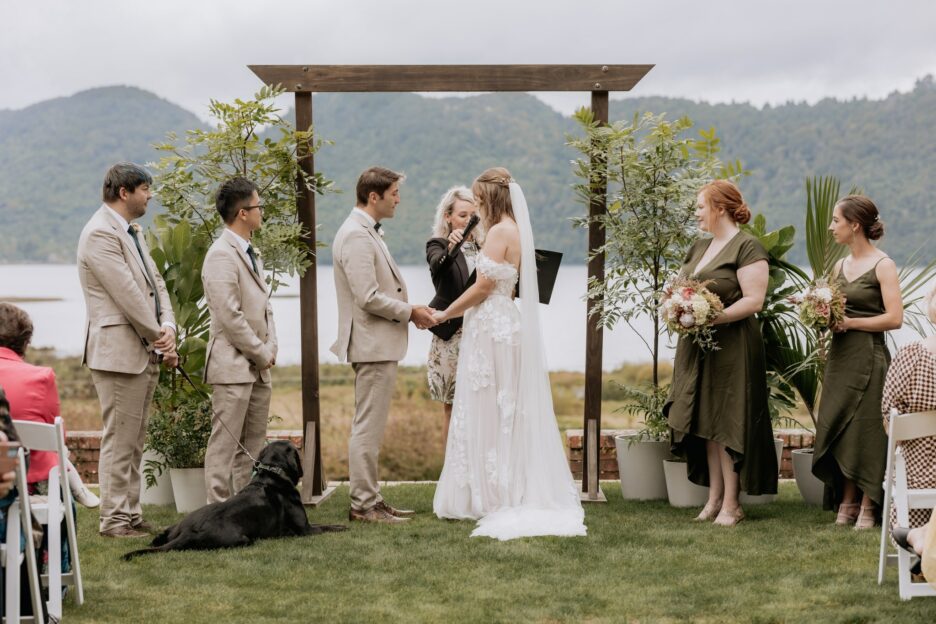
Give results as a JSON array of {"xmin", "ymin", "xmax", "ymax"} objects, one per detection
[{"xmin": 0, "ymin": 87, "xmax": 201, "ymax": 263}]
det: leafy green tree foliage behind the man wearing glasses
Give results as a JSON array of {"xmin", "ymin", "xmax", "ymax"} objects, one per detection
[{"xmin": 147, "ymin": 87, "xmax": 333, "ymax": 468}]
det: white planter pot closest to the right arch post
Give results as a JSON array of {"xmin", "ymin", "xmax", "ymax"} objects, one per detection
[{"xmin": 614, "ymin": 435, "xmax": 672, "ymax": 500}]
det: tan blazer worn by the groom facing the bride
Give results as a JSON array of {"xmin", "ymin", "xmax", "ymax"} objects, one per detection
[{"xmin": 331, "ymin": 212, "xmax": 413, "ymax": 362}]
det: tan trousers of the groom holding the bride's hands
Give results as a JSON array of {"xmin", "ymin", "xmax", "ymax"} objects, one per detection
[{"xmin": 348, "ymin": 362, "xmax": 397, "ymax": 511}]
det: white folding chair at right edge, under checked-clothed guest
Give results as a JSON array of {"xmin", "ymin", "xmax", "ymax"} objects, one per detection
[{"xmin": 878, "ymin": 409, "xmax": 936, "ymax": 600}]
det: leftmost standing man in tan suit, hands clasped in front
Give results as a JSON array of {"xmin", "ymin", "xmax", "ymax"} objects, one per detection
[{"xmin": 78, "ymin": 163, "xmax": 178, "ymax": 537}]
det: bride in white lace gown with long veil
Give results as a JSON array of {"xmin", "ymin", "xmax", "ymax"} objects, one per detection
[{"xmin": 433, "ymin": 167, "xmax": 586, "ymax": 540}]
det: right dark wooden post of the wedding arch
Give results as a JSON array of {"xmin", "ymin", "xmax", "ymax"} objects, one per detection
[{"xmin": 582, "ymin": 91, "xmax": 608, "ymax": 502}]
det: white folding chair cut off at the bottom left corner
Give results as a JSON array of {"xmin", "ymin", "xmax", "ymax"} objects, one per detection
[{"xmin": 3, "ymin": 449, "xmax": 43, "ymax": 624}]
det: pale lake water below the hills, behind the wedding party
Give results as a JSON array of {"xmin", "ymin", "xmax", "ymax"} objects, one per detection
[{"xmin": 0, "ymin": 264, "xmax": 917, "ymax": 371}]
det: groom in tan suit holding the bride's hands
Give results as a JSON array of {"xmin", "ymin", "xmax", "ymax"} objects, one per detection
[{"xmin": 331, "ymin": 167, "xmax": 434, "ymax": 523}]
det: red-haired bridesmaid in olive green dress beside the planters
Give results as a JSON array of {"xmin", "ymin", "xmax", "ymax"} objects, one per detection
[{"xmin": 664, "ymin": 180, "xmax": 778, "ymax": 526}]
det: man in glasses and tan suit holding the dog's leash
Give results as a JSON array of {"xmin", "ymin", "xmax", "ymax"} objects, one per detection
[{"xmin": 202, "ymin": 178, "xmax": 276, "ymax": 503}]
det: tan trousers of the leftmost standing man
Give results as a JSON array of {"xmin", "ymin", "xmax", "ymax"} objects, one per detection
[{"xmin": 91, "ymin": 364, "xmax": 159, "ymax": 531}]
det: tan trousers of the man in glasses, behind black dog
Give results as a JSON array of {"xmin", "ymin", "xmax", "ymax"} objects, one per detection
[{"xmin": 205, "ymin": 379, "xmax": 273, "ymax": 503}]
